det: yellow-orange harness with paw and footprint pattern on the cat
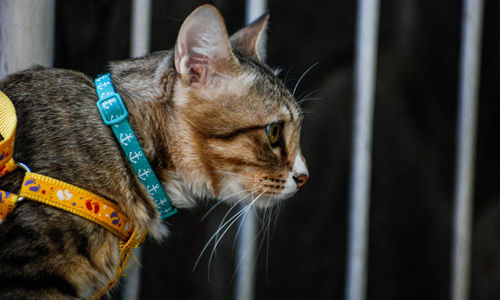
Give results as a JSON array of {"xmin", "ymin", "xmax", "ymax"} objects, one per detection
[{"xmin": 0, "ymin": 91, "xmax": 146, "ymax": 299}]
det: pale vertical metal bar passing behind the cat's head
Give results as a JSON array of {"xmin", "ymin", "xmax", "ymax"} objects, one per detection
[{"xmin": 234, "ymin": 0, "xmax": 267, "ymax": 300}]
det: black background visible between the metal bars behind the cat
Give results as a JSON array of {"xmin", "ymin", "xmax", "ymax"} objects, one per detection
[{"xmin": 55, "ymin": 0, "xmax": 500, "ymax": 299}]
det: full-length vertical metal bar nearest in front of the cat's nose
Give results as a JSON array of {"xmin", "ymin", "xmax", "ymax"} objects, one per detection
[{"xmin": 345, "ymin": 0, "xmax": 379, "ymax": 300}]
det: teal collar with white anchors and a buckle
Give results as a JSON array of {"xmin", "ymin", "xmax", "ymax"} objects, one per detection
[{"xmin": 95, "ymin": 73, "xmax": 177, "ymax": 220}]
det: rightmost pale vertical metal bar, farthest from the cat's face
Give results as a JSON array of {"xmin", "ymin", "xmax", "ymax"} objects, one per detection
[{"xmin": 451, "ymin": 0, "xmax": 483, "ymax": 300}]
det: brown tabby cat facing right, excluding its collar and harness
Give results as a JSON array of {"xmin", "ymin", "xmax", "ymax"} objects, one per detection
[{"xmin": 0, "ymin": 4, "xmax": 309, "ymax": 299}]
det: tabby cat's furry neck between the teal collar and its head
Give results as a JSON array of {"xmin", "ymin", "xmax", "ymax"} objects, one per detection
[{"xmin": 106, "ymin": 51, "xmax": 206, "ymax": 208}]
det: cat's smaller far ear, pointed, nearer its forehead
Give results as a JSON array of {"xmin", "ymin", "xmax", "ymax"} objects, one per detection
[{"xmin": 230, "ymin": 13, "xmax": 269, "ymax": 61}]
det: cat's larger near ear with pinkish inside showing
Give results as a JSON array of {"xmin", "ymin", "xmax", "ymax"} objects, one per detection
[{"xmin": 174, "ymin": 4, "xmax": 239, "ymax": 87}]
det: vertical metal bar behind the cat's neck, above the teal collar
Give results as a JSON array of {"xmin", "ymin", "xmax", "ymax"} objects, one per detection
[{"xmin": 122, "ymin": 0, "xmax": 151, "ymax": 300}]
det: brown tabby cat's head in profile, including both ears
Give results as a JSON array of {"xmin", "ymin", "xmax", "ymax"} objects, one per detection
[{"xmin": 167, "ymin": 5, "xmax": 309, "ymax": 207}]
